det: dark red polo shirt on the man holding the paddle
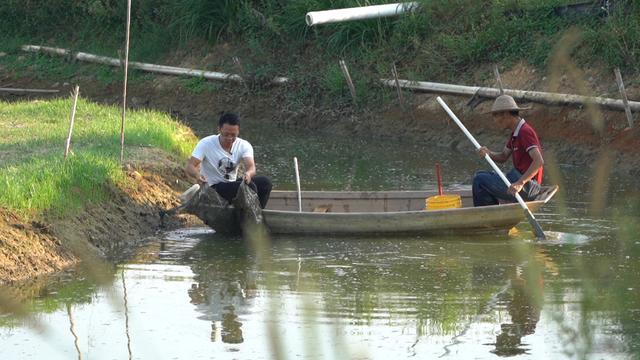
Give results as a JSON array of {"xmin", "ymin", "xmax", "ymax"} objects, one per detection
[{"xmin": 507, "ymin": 119, "xmax": 542, "ymax": 184}]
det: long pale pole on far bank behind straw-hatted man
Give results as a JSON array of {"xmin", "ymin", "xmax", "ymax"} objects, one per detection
[{"xmin": 380, "ymin": 79, "xmax": 640, "ymax": 112}]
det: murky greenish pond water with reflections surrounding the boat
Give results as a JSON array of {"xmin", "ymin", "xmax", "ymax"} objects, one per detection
[{"xmin": 0, "ymin": 129, "xmax": 640, "ymax": 359}]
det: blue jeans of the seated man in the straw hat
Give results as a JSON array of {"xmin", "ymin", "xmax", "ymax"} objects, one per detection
[{"xmin": 472, "ymin": 169, "xmax": 540, "ymax": 206}]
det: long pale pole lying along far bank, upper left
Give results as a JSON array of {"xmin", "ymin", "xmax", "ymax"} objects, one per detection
[{"xmin": 22, "ymin": 45, "xmax": 289, "ymax": 85}]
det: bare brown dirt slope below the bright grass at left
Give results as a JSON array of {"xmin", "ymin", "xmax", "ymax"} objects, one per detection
[{"xmin": 0, "ymin": 148, "xmax": 198, "ymax": 285}]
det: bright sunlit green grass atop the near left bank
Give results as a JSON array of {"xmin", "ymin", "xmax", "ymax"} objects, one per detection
[{"xmin": 0, "ymin": 99, "xmax": 196, "ymax": 217}]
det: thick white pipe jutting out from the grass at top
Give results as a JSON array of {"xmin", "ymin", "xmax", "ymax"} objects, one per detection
[{"xmin": 305, "ymin": 2, "xmax": 418, "ymax": 26}]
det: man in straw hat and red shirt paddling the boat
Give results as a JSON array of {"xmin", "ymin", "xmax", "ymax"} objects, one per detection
[{"xmin": 472, "ymin": 95, "xmax": 544, "ymax": 206}]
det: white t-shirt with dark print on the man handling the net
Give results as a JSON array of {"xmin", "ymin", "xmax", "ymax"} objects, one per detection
[{"xmin": 191, "ymin": 135, "xmax": 253, "ymax": 186}]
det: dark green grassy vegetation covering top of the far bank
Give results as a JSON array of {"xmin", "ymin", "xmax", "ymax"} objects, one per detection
[{"xmin": 0, "ymin": 0, "xmax": 640, "ymax": 106}]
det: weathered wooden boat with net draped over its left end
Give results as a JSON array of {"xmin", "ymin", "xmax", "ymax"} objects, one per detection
[{"xmin": 178, "ymin": 186, "xmax": 558, "ymax": 235}]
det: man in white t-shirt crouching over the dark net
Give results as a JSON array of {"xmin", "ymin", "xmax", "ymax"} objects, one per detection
[{"xmin": 185, "ymin": 112, "xmax": 271, "ymax": 208}]
